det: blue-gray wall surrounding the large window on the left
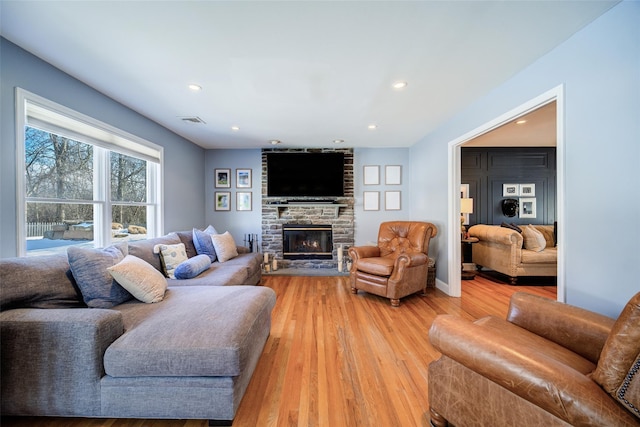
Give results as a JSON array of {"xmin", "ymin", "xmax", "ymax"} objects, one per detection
[{"xmin": 0, "ymin": 38, "xmax": 205, "ymax": 257}]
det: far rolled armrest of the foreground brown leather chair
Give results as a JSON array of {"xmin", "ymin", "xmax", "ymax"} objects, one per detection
[{"xmin": 507, "ymin": 292, "xmax": 615, "ymax": 364}]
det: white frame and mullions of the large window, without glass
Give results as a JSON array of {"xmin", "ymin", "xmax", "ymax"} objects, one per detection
[{"xmin": 16, "ymin": 87, "xmax": 164, "ymax": 256}]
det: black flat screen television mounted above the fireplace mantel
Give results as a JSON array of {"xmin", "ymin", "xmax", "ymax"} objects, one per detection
[{"xmin": 267, "ymin": 152, "xmax": 344, "ymax": 197}]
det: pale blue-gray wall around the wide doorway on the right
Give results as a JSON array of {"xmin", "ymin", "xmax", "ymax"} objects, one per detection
[{"xmin": 410, "ymin": 2, "xmax": 640, "ymax": 316}]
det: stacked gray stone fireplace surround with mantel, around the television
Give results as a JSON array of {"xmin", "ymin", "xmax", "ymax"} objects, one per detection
[{"xmin": 262, "ymin": 149, "xmax": 355, "ymax": 268}]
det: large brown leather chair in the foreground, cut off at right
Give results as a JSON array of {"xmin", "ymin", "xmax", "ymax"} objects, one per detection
[{"xmin": 428, "ymin": 292, "xmax": 640, "ymax": 427}]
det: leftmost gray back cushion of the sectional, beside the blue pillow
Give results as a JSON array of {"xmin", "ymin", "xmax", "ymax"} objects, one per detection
[{"xmin": 0, "ymin": 253, "xmax": 86, "ymax": 311}]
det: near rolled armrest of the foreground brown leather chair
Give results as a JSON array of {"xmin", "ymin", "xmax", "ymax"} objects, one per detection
[{"xmin": 429, "ymin": 315, "xmax": 636, "ymax": 425}]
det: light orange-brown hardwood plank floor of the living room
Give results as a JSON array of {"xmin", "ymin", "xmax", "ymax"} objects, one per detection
[{"xmin": 2, "ymin": 276, "xmax": 556, "ymax": 427}]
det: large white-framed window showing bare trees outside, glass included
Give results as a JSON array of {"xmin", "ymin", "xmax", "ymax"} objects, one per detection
[{"xmin": 16, "ymin": 89, "xmax": 162, "ymax": 255}]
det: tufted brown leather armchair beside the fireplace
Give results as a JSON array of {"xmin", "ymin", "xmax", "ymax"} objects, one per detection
[{"xmin": 349, "ymin": 221, "xmax": 437, "ymax": 307}]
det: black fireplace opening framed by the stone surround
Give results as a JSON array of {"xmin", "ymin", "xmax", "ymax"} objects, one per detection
[{"xmin": 282, "ymin": 224, "xmax": 333, "ymax": 259}]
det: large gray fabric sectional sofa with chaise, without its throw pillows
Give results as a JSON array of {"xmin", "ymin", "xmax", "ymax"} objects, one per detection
[{"xmin": 0, "ymin": 232, "xmax": 275, "ymax": 423}]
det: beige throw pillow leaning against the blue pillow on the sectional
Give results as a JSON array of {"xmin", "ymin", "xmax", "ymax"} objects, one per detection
[{"xmin": 107, "ymin": 255, "xmax": 167, "ymax": 303}]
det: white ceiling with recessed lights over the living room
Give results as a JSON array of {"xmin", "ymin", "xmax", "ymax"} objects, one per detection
[{"xmin": 0, "ymin": 0, "xmax": 617, "ymax": 148}]
